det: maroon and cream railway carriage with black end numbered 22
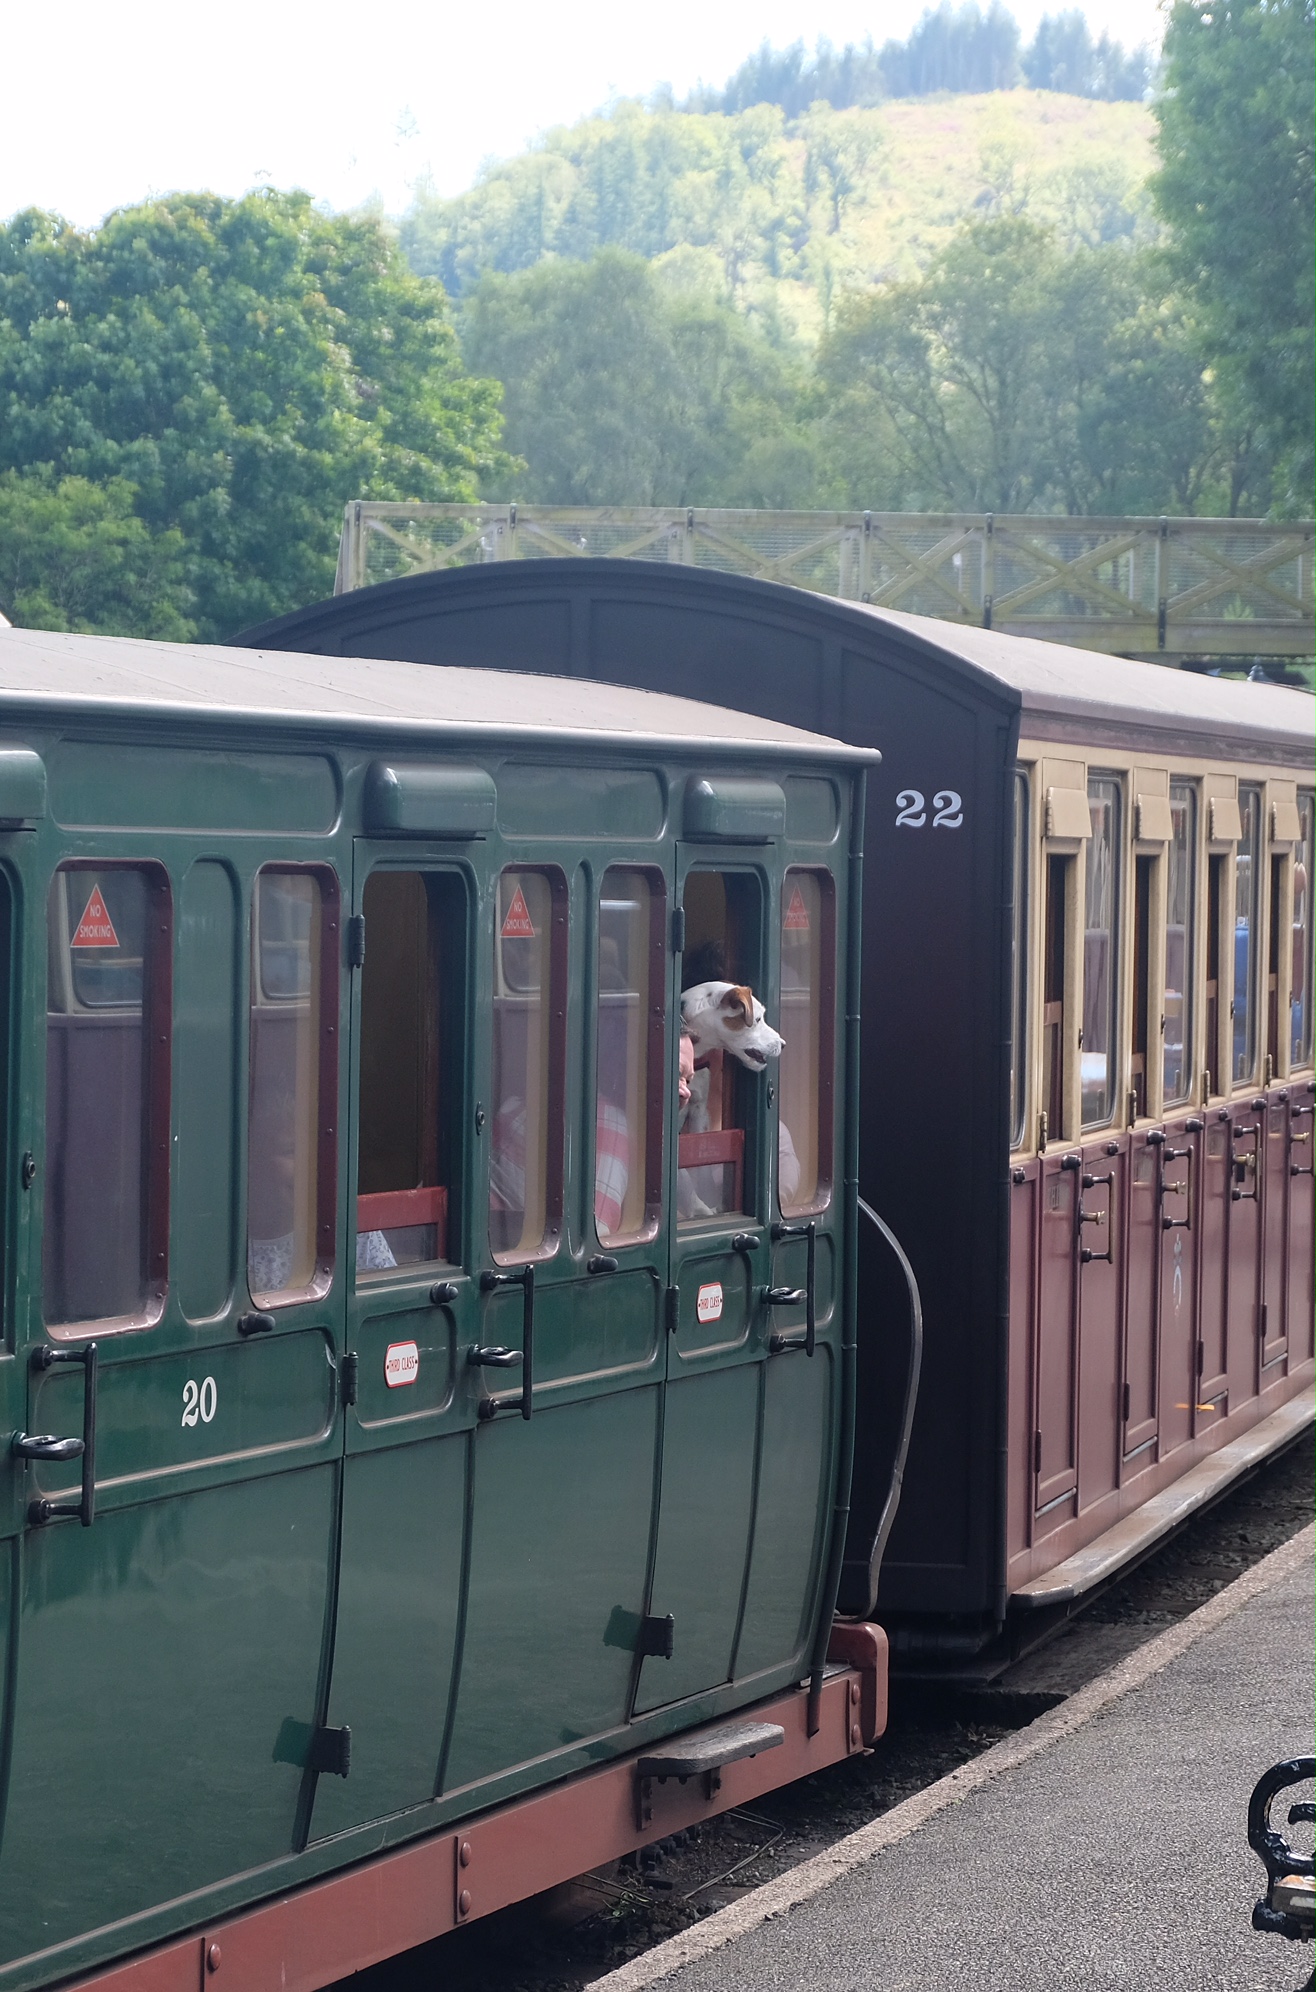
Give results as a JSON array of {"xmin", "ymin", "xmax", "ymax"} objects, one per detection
[{"xmin": 243, "ymin": 560, "xmax": 1316, "ymax": 1671}]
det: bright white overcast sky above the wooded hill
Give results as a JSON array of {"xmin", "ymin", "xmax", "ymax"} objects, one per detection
[{"xmin": 0, "ymin": 0, "xmax": 1161, "ymax": 225}]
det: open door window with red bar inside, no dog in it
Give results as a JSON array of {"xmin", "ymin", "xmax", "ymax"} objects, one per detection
[{"xmin": 356, "ymin": 871, "xmax": 464, "ymax": 1275}]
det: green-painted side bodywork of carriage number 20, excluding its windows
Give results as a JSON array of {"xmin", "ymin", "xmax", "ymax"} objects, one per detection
[{"xmin": 0, "ymin": 709, "xmax": 864, "ymax": 1992}]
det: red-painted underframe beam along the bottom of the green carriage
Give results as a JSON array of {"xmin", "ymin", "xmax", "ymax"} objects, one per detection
[{"xmin": 58, "ymin": 1625, "xmax": 886, "ymax": 1992}]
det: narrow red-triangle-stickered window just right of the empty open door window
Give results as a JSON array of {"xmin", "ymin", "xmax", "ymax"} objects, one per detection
[{"xmin": 490, "ymin": 871, "xmax": 567, "ymax": 1259}]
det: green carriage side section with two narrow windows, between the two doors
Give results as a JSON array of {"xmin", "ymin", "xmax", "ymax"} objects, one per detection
[{"xmin": 444, "ymin": 860, "xmax": 671, "ymax": 1791}]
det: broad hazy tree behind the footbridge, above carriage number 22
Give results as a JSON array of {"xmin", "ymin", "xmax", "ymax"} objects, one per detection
[{"xmin": 818, "ymin": 215, "xmax": 1256, "ymax": 514}]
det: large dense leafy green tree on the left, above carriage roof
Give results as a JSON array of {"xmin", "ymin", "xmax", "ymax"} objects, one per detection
[{"xmin": 0, "ymin": 191, "xmax": 504, "ymax": 637}]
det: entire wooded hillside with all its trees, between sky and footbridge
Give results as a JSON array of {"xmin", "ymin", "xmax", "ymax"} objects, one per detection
[{"xmin": 0, "ymin": 0, "xmax": 1316, "ymax": 635}]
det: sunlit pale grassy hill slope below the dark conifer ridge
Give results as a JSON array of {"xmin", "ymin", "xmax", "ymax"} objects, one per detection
[{"xmin": 402, "ymin": 90, "xmax": 1153, "ymax": 343}]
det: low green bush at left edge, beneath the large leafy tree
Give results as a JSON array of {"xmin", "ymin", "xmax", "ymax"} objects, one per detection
[{"xmin": 0, "ymin": 470, "xmax": 195, "ymax": 641}]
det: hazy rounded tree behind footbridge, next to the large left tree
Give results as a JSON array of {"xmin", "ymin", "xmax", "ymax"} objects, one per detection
[{"xmin": 462, "ymin": 249, "xmax": 808, "ymax": 506}]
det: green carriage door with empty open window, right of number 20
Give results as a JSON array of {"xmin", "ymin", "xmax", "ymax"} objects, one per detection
[{"xmin": 304, "ymin": 843, "xmax": 476, "ymax": 1839}]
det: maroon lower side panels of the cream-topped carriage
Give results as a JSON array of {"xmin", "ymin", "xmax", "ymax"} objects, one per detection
[{"xmin": 1007, "ymin": 1082, "xmax": 1316, "ymax": 1590}]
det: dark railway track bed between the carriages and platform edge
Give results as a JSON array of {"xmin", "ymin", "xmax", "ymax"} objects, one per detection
[{"xmin": 336, "ymin": 1432, "xmax": 1316, "ymax": 1992}]
